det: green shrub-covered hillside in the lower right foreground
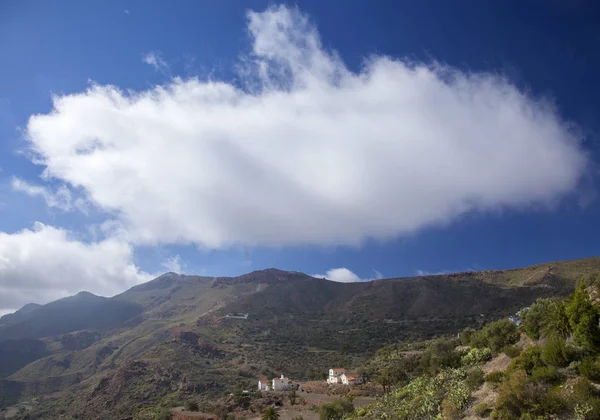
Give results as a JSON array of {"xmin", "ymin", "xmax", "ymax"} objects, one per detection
[{"xmin": 351, "ymin": 282, "xmax": 600, "ymax": 420}]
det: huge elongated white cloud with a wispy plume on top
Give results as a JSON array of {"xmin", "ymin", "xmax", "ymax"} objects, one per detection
[{"xmin": 22, "ymin": 7, "xmax": 587, "ymax": 248}]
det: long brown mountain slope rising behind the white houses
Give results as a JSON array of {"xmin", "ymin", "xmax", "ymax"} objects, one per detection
[{"xmin": 0, "ymin": 258, "xmax": 600, "ymax": 418}]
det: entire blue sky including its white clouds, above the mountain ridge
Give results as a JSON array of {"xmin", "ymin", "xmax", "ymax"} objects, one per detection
[{"xmin": 0, "ymin": 1, "xmax": 600, "ymax": 311}]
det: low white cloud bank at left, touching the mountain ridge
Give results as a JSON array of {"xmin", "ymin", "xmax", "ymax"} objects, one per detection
[{"xmin": 0, "ymin": 223, "xmax": 152, "ymax": 311}]
